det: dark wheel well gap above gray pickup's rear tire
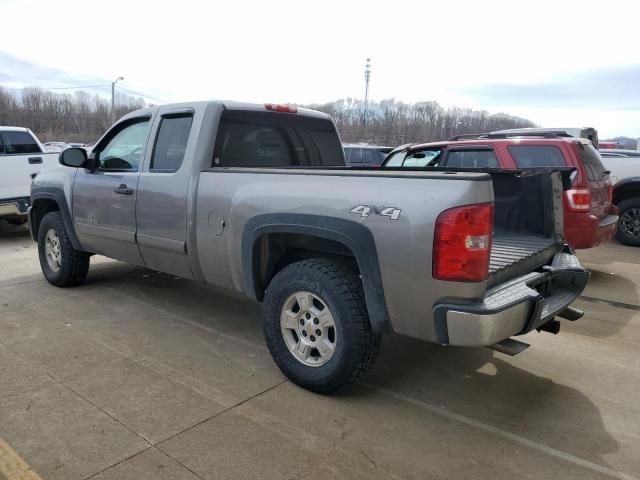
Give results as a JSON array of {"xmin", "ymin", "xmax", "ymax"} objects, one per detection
[{"xmin": 252, "ymin": 233, "xmax": 360, "ymax": 301}]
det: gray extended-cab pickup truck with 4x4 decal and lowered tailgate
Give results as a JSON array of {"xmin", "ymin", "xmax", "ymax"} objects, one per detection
[{"xmin": 29, "ymin": 101, "xmax": 589, "ymax": 393}]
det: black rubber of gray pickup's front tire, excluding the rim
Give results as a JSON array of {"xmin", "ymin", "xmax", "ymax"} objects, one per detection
[{"xmin": 38, "ymin": 212, "xmax": 90, "ymax": 287}]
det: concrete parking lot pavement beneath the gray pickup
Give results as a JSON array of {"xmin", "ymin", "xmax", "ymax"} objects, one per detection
[{"xmin": 0, "ymin": 222, "xmax": 640, "ymax": 480}]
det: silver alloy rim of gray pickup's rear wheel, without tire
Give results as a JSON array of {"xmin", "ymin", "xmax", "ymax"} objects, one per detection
[{"xmin": 280, "ymin": 291, "xmax": 336, "ymax": 367}]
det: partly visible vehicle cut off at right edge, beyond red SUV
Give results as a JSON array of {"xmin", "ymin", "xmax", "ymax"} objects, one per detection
[{"xmin": 600, "ymin": 150, "xmax": 640, "ymax": 247}]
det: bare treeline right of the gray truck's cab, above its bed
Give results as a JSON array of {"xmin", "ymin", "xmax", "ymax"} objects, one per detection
[{"xmin": 305, "ymin": 98, "xmax": 535, "ymax": 146}]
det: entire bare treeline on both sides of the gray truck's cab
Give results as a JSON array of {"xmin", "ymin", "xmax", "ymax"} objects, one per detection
[{"xmin": 0, "ymin": 87, "xmax": 535, "ymax": 146}]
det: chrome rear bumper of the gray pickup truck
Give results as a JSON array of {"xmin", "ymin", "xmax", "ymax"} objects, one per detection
[{"xmin": 433, "ymin": 248, "xmax": 589, "ymax": 346}]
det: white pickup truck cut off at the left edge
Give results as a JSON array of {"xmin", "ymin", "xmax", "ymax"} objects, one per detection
[{"xmin": 0, "ymin": 126, "xmax": 58, "ymax": 225}]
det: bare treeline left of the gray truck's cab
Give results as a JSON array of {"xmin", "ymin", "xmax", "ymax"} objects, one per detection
[{"xmin": 0, "ymin": 87, "xmax": 145, "ymax": 143}]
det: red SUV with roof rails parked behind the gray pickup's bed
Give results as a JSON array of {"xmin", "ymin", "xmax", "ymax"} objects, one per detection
[{"xmin": 382, "ymin": 134, "xmax": 618, "ymax": 248}]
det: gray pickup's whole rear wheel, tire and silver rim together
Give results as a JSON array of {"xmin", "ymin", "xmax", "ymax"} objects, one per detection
[{"xmin": 263, "ymin": 259, "xmax": 380, "ymax": 393}]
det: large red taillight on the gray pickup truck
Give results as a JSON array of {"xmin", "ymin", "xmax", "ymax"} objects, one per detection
[{"xmin": 433, "ymin": 203, "xmax": 493, "ymax": 282}]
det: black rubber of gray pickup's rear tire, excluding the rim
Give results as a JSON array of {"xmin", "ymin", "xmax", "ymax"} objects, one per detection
[{"xmin": 263, "ymin": 259, "xmax": 380, "ymax": 394}]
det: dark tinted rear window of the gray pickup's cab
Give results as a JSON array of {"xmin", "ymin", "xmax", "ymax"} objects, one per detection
[{"xmin": 212, "ymin": 110, "xmax": 345, "ymax": 168}]
